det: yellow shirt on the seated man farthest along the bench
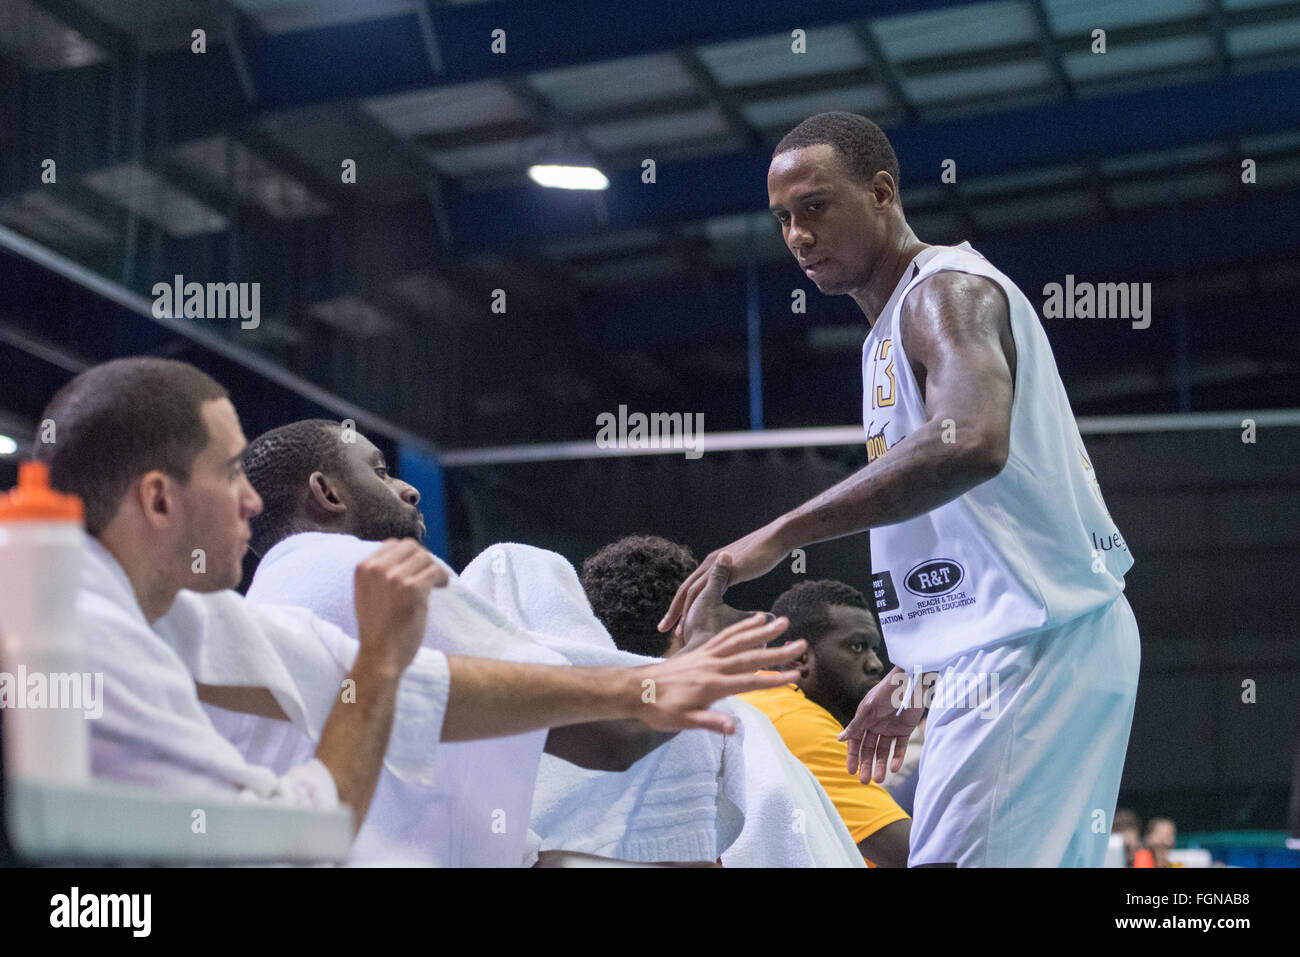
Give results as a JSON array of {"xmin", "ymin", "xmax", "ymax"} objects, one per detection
[{"xmin": 737, "ymin": 684, "xmax": 907, "ymax": 858}]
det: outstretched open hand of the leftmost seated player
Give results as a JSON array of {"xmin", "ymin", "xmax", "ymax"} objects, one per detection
[{"xmin": 633, "ymin": 614, "xmax": 807, "ymax": 735}]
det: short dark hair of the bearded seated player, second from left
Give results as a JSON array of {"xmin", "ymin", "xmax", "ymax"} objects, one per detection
[{"xmin": 243, "ymin": 419, "xmax": 342, "ymax": 555}]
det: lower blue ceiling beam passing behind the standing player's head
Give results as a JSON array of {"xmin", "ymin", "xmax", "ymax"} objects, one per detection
[{"xmin": 451, "ymin": 69, "xmax": 1300, "ymax": 248}]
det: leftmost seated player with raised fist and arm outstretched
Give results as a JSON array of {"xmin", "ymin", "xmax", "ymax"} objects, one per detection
[{"xmin": 36, "ymin": 358, "xmax": 792, "ymax": 858}]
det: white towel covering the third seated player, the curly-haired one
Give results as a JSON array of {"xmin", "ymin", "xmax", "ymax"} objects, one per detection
[{"xmin": 462, "ymin": 544, "xmax": 865, "ymax": 867}]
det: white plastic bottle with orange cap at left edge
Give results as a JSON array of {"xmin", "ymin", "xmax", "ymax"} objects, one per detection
[{"xmin": 0, "ymin": 462, "xmax": 87, "ymax": 787}]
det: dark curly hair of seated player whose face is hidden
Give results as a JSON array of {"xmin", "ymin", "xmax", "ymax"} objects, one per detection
[{"xmin": 580, "ymin": 534, "xmax": 699, "ymax": 658}]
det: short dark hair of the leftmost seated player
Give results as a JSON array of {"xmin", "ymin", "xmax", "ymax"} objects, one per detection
[{"xmin": 34, "ymin": 356, "xmax": 228, "ymax": 536}]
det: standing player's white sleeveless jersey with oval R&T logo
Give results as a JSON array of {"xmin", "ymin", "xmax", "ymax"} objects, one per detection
[{"xmin": 862, "ymin": 243, "xmax": 1132, "ymax": 674}]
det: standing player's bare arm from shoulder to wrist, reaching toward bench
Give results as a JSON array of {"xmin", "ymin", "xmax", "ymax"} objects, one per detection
[{"xmin": 774, "ymin": 272, "xmax": 1015, "ymax": 551}]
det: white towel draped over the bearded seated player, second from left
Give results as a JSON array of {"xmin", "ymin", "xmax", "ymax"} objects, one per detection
[{"xmin": 227, "ymin": 532, "xmax": 566, "ymax": 867}]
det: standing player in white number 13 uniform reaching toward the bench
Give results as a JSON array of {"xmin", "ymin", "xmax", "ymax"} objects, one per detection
[{"xmin": 660, "ymin": 113, "xmax": 1139, "ymax": 866}]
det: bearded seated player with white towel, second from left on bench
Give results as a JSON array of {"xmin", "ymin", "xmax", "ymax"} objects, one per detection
[{"xmin": 227, "ymin": 419, "xmax": 806, "ymax": 866}]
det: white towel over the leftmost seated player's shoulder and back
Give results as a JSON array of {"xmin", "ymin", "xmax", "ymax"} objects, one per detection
[{"xmin": 77, "ymin": 536, "xmax": 338, "ymax": 809}]
